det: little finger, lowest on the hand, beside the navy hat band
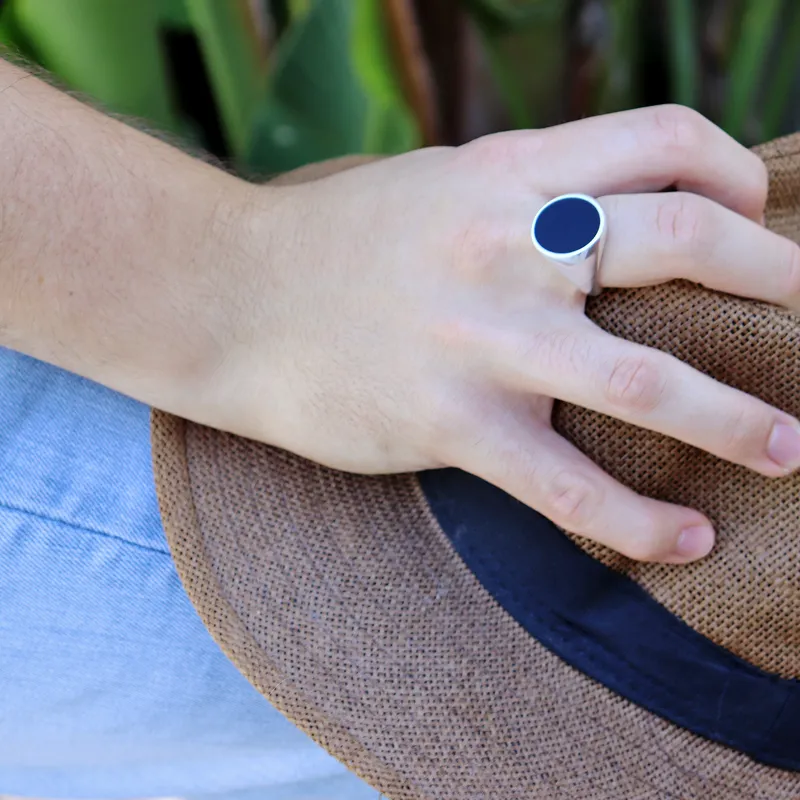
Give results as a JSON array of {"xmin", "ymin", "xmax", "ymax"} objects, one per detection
[{"xmin": 457, "ymin": 418, "xmax": 714, "ymax": 564}]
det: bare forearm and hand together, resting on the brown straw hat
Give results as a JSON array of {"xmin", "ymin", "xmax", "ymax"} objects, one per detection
[{"xmin": 0, "ymin": 62, "xmax": 800, "ymax": 563}]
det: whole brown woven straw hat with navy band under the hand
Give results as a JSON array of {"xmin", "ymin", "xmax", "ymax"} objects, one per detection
[{"xmin": 152, "ymin": 136, "xmax": 800, "ymax": 800}]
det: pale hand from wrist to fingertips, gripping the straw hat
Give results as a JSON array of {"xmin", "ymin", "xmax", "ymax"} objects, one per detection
[{"xmin": 192, "ymin": 107, "xmax": 800, "ymax": 562}]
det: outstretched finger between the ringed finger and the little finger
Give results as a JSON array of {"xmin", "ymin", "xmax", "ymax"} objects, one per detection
[{"xmin": 501, "ymin": 312, "xmax": 800, "ymax": 477}]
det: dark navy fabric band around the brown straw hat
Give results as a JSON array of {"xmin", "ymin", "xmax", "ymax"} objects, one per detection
[{"xmin": 420, "ymin": 469, "xmax": 800, "ymax": 771}]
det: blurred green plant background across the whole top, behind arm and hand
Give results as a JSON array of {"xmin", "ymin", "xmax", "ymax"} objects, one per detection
[{"xmin": 0, "ymin": 0, "xmax": 800, "ymax": 174}]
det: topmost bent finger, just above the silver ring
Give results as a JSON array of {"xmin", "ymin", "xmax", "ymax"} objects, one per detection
[{"xmin": 521, "ymin": 105, "xmax": 768, "ymax": 221}]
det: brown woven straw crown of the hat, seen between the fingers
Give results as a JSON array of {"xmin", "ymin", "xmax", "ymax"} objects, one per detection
[{"xmin": 555, "ymin": 131, "xmax": 800, "ymax": 678}]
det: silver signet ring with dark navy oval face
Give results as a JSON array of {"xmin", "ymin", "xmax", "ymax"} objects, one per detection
[{"xmin": 531, "ymin": 194, "xmax": 606, "ymax": 294}]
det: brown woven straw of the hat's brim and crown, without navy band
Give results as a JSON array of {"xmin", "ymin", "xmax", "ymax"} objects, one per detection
[{"xmin": 152, "ymin": 134, "xmax": 800, "ymax": 800}]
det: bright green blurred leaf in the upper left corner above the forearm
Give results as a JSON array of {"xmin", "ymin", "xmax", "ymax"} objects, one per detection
[{"xmin": 13, "ymin": 0, "xmax": 179, "ymax": 131}]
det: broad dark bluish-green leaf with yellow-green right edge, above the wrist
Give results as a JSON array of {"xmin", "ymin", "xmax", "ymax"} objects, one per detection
[{"xmin": 246, "ymin": 0, "xmax": 421, "ymax": 174}]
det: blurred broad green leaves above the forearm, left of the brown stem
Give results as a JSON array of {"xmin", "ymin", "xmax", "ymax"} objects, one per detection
[{"xmin": 0, "ymin": 0, "xmax": 421, "ymax": 174}]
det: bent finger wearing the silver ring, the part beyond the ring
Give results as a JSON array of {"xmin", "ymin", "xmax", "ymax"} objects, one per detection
[{"xmin": 598, "ymin": 192, "xmax": 800, "ymax": 310}]
